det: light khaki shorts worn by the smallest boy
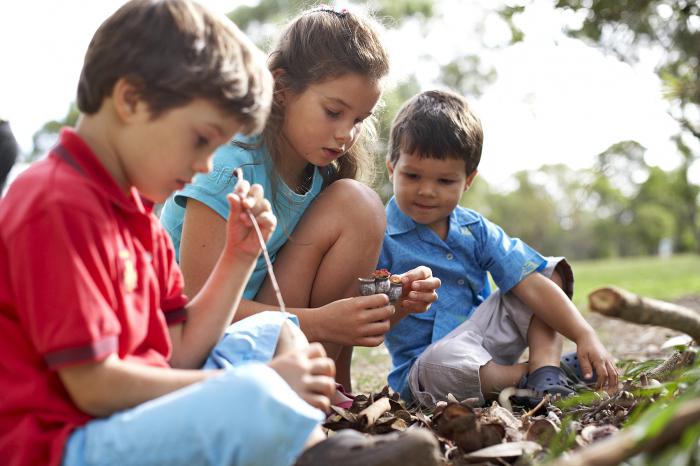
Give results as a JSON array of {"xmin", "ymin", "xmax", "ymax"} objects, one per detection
[{"xmin": 408, "ymin": 257, "xmax": 574, "ymax": 407}]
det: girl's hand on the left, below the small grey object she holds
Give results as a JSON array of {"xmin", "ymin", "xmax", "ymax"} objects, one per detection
[{"xmin": 316, "ymin": 294, "xmax": 395, "ymax": 346}]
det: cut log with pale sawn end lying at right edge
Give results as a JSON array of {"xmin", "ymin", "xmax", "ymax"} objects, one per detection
[{"xmin": 588, "ymin": 287, "xmax": 700, "ymax": 341}]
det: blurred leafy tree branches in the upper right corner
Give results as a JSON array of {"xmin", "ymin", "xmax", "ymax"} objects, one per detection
[{"xmin": 532, "ymin": 0, "xmax": 700, "ymax": 252}]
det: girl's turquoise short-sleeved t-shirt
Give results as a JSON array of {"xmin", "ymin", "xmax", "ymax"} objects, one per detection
[{"xmin": 160, "ymin": 136, "xmax": 323, "ymax": 299}]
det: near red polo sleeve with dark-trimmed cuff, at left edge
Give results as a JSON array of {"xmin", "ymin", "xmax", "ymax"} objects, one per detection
[{"xmin": 8, "ymin": 206, "xmax": 121, "ymax": 369}]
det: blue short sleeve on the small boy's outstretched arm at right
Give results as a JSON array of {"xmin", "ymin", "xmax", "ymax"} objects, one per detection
[{"xmin": 476, "ymin": 217, "xmax": 547, "ymax": 293}]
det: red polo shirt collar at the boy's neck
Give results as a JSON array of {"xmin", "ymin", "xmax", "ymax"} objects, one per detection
[{"xmin": 51, "ymin": 128, "xmax": 146, "ymax": 213}]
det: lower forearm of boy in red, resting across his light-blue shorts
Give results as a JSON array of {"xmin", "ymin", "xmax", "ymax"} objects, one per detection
[{"xmin": 58, "ymin": 354, "xmax": 221, "ymax": 417}]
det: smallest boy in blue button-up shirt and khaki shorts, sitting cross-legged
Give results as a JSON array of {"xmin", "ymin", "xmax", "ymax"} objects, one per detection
[{"xmin": 378, "ymin": 91, "xmax": 617, "ymax": 406}]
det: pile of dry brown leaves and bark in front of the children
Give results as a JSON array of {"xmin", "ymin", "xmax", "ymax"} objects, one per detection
[{"xmin": 324, "ymin": 381, "xmax": 651, "ymax": 465}]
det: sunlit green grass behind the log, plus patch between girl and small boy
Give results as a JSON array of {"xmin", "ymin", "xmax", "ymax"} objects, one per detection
[{"xmin": 352, "ymin": 255, "xmax": 700, "ymax": 393}]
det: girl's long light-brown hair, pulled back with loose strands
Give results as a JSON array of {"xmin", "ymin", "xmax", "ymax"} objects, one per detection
[{"xmin": 262, "ymin": 6, "xmax": 389, "ymax": 184}]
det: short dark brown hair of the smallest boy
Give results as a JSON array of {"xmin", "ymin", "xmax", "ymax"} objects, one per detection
[{"xmin": 387, "ymin": 90, "xmax": 484, "ymax": 176}]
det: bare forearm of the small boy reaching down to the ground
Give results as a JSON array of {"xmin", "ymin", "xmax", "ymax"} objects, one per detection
[{"xmin": 512, "ymin": 273, "xmax": 594, "ymax": 342}]
